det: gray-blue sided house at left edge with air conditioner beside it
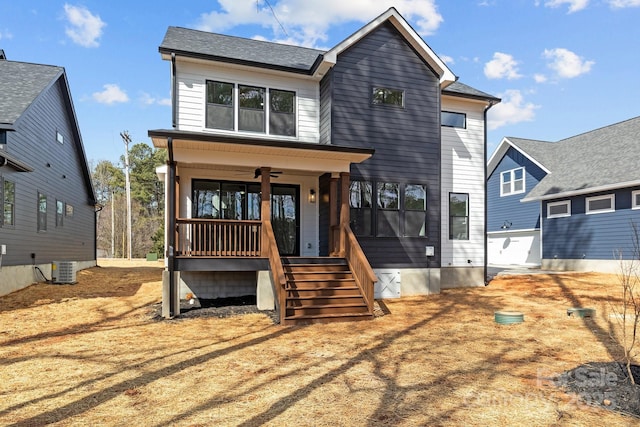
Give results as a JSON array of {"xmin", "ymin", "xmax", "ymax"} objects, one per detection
[{"xmin": 0, "ymin": 51, "xmax": 96, "ymax": 295}]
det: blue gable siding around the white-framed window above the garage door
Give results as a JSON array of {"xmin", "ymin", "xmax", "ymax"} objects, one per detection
[{"xmin": 487, "ymin": 148, "xmax": 546, "ymax": 231}]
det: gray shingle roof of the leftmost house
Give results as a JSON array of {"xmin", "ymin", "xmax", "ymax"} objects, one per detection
[{"xmin": 0, "ymin": 60, "xmax": 64, "ymax": 125}]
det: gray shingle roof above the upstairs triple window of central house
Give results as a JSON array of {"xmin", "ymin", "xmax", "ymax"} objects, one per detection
[{"xmin": 160, "ymin": 27, "xmax": 325, "ymax": 73}]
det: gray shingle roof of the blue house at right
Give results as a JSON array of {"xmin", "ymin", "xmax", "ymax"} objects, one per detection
[{"xmin": 509, "ymin": 117, "xmax": 640, "ymax": 200}]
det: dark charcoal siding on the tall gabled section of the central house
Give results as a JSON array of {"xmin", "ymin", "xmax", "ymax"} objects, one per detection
[{"xmin": 331, "ymin": 23, "xmax": 440, "ymax": 268}]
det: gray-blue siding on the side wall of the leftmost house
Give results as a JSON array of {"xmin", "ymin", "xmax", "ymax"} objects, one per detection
[{"xmin": 0, "ymin": 79, "xmax": 95, "ymax": 265}]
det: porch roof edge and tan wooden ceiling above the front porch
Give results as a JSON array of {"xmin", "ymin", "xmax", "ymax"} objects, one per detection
[{"xmin": 149, "ymin": 130, "xmax": 374, "ymax": 172}]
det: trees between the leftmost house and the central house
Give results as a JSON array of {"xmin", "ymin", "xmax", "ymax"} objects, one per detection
[{"xmin": 91, "ymin": 143, "xmax": 167, "ymax": 258}]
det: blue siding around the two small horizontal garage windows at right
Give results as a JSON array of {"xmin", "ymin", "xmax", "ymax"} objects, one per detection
[{"xmin": 542, "ymin": 187, "xmax": 640, "ymax": 260}]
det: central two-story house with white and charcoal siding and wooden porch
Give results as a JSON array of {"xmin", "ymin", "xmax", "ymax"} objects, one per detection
[{"xmin": 149, "ymin": 8, "xmax": 499, "ymax": 323}]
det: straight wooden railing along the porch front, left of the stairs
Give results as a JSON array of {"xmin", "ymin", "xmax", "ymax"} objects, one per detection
[{"xmin": 176, "ymin": 218, "xmax": 262, "ymax": 258}]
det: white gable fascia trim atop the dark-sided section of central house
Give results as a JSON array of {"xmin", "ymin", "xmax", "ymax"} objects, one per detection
[{"xmin": 319, "ymin": 7, "xmax": 458, "ymax": 88}]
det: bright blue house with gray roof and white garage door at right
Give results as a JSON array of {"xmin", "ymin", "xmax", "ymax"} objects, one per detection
[{"xmin": 487, "ymin": 117, "xmax": 640, "ymax": 272}]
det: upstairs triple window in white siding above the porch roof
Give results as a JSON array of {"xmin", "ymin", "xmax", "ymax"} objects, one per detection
[{"xmin": 205, "ymin": 81, "xmax": 297, "ymax": 136}]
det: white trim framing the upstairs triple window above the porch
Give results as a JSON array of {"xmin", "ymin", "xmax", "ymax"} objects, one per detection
[{"xmin": 203, "ymin": 79, "xmax": 299, "ymax": 139}]
